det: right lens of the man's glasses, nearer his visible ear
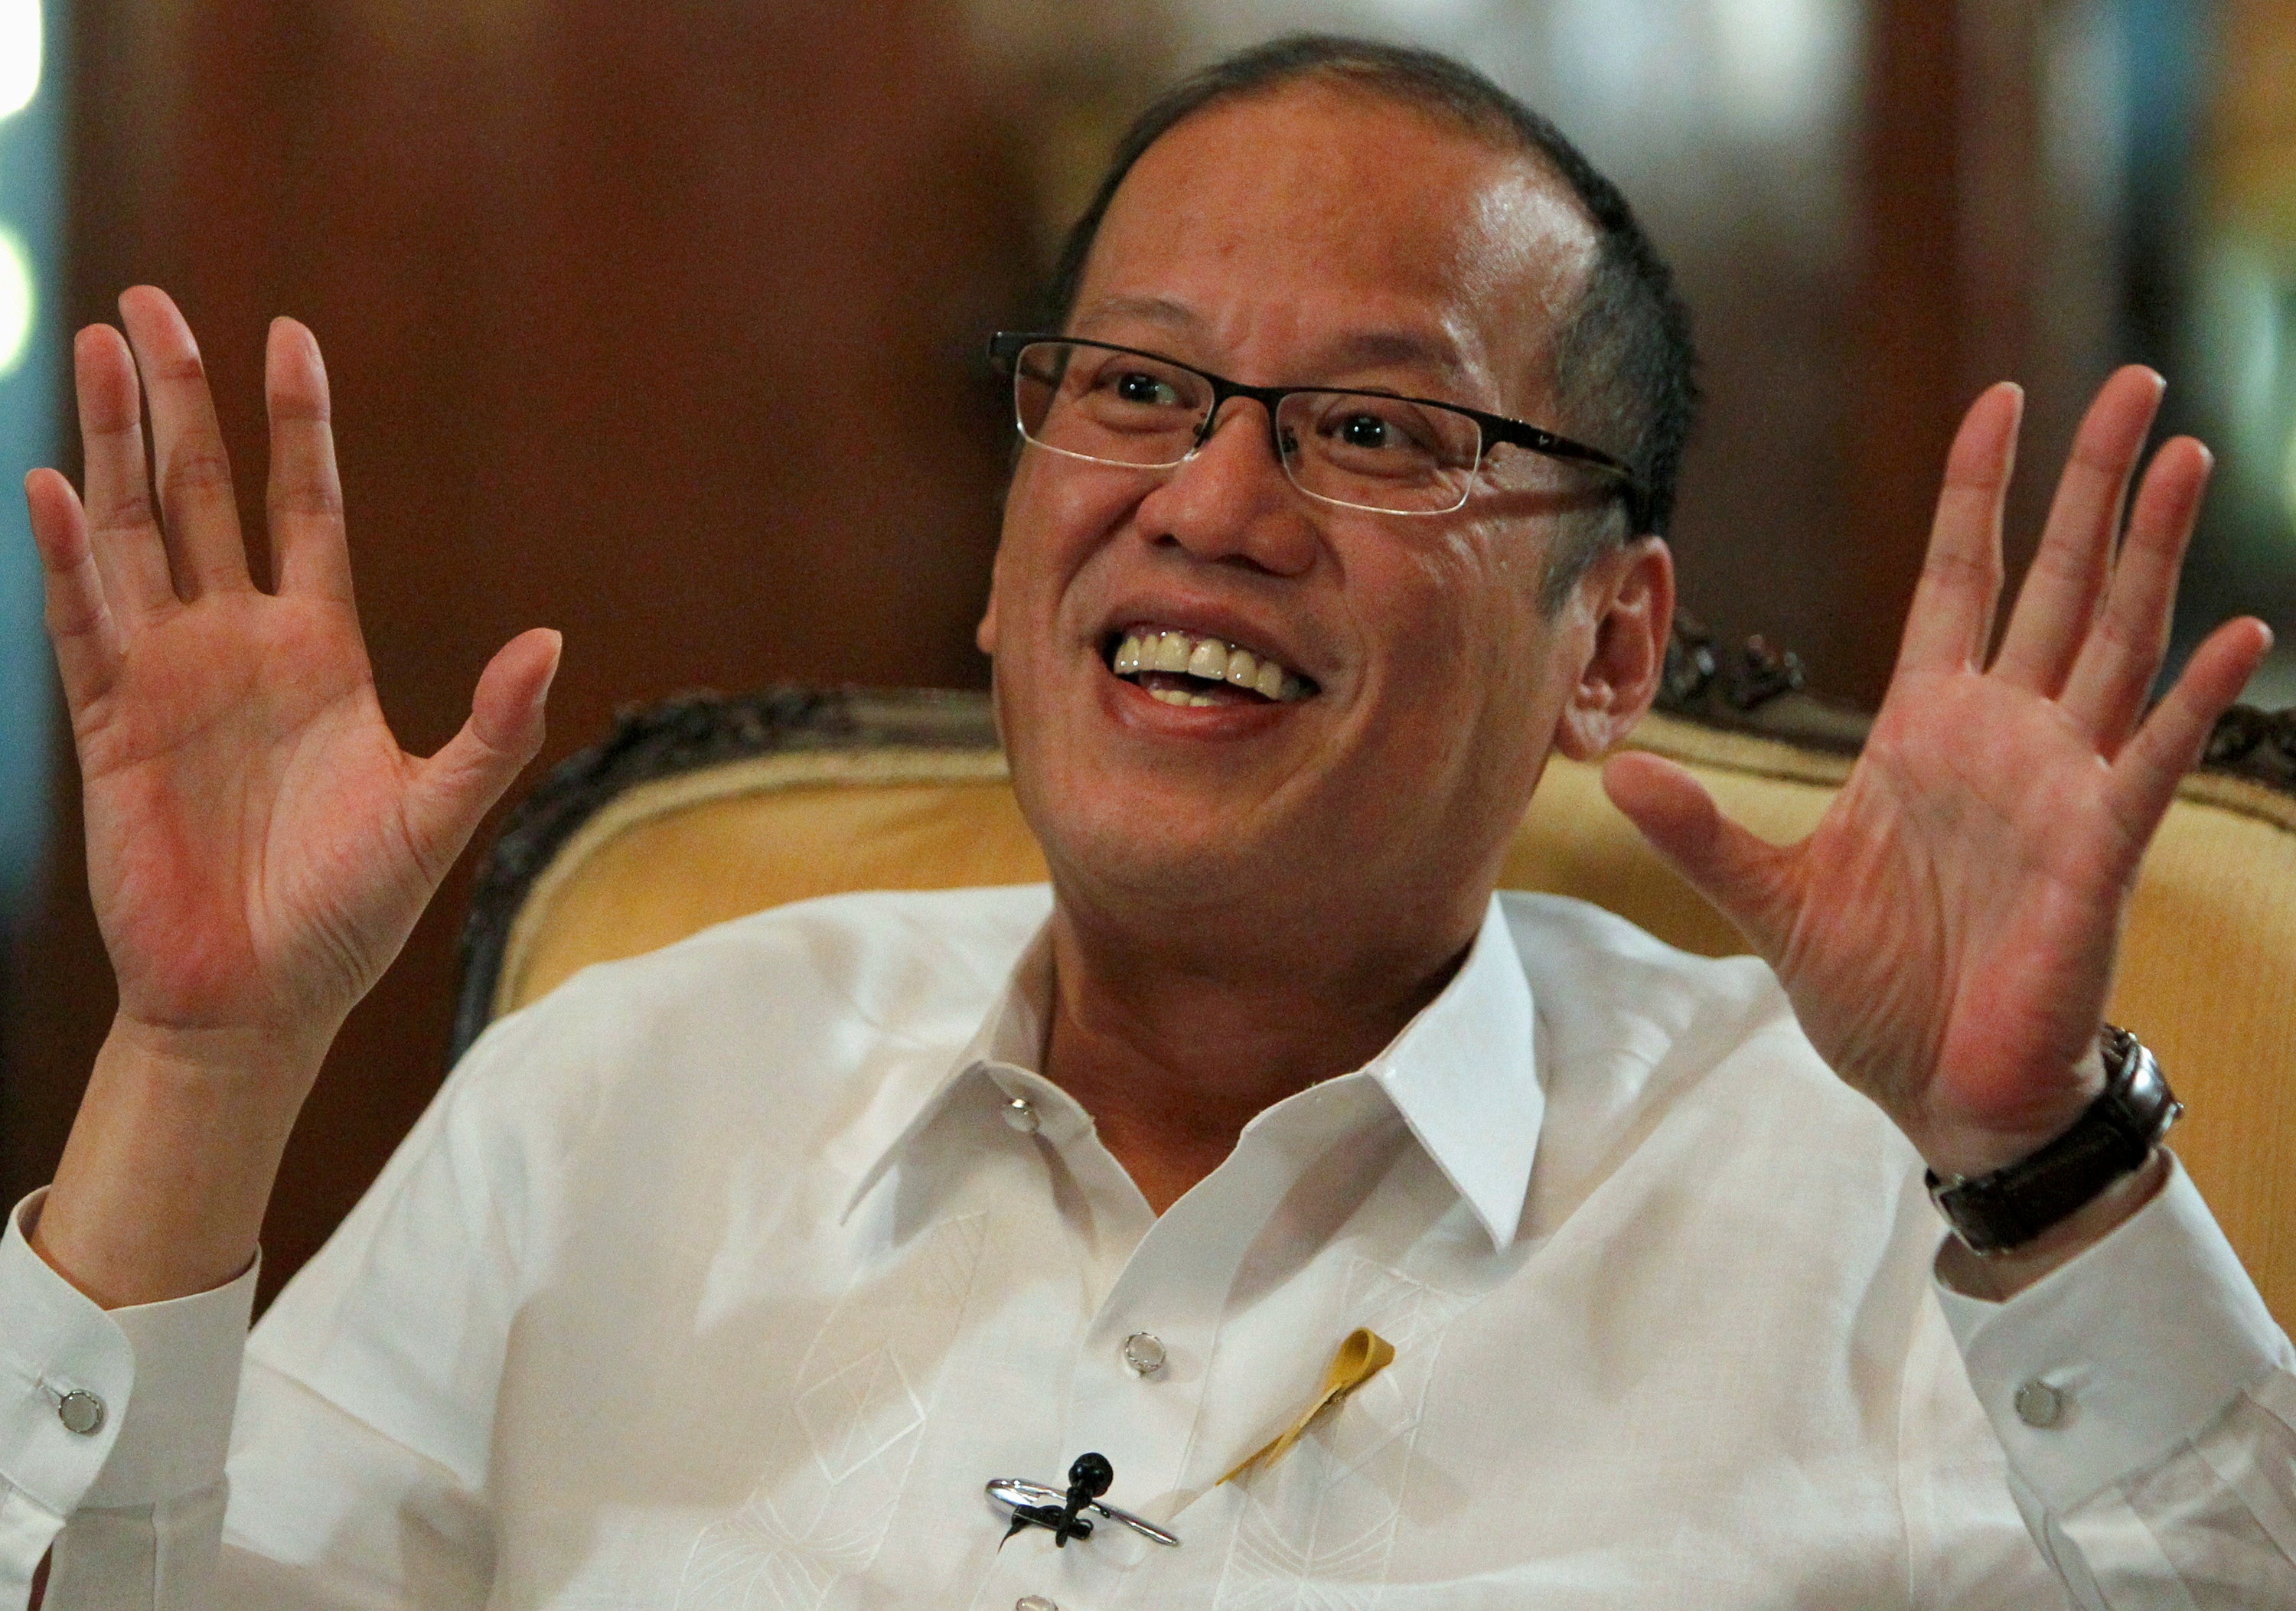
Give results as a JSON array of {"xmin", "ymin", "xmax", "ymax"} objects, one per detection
[{"xmin": 1277, "ymin": 393, "xmax": 1483, "ymax": 514}]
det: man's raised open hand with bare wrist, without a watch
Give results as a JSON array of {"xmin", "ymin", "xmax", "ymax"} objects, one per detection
[{"xmin": 25, "ymin": 287, "xmax": 558, "ymax": 1294}]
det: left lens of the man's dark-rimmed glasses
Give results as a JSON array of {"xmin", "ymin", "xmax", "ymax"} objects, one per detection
[{"xmin": 1013, "ymin": 342, "xmax": 1212, "ymax": 466}]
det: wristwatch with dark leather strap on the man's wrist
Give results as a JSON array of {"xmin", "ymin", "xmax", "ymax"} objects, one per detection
[{"xmin": 1926, "ymin": 1023, "xmax": 2183, "ymax": 1253}]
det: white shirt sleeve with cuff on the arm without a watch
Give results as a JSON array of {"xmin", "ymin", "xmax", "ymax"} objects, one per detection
[{"xmin": 0, "ymin": 996, "xmax": 560, "ymax": 1611}]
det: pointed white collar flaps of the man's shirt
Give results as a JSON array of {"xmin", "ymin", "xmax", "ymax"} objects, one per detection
[{"xmin": 838, "ymin": 895, "xmax": 1545, "ymax": 1248}]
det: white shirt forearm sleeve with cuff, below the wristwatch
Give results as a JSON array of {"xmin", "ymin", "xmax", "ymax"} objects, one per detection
[{"xmin": 1936, "ymin": 1156, "xmax": 2296, "ymax": 1611}]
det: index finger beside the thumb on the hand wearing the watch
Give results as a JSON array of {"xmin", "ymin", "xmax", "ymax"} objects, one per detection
[{"xmin": 1896, "ymin": 381, "xmax": 2025, "ymax": 673}]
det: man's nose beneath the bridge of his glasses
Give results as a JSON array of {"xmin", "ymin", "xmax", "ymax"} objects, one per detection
[{"xmin": 1139, "ymin": 397, "xmax": 1318, "ymax": 576}]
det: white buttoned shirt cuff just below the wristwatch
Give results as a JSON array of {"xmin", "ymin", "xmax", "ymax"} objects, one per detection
[{"xmin": 1933, "ymin": 1154, "xmax": 2296, "ymax": 1515}]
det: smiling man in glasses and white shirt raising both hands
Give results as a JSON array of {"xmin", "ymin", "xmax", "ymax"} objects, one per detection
[{"xmin": 0, "ymin": 41, "xmax": 2296, "ymax": 1611}]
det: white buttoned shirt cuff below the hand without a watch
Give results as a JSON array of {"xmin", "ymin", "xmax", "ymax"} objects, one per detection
[{"xmin": 0, "ymin": 1189, "xmax": 259, "ymax": 1515}]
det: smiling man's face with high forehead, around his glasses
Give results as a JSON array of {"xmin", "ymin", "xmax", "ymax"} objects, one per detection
[{"xmin": 980, "ymin": 85, "xmax": 1644, "ymax": 950}]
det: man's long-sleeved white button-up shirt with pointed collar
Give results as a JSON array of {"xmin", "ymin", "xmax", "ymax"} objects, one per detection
[{"xmin": 0, "ymin": 888, "xmax": 2296, "ymax": 1611}]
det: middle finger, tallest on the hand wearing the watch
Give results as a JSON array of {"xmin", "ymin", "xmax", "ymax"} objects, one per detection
[{"xmin": 1993, "ymin": 365, "xmax": 2167, "ymax": 698}]
